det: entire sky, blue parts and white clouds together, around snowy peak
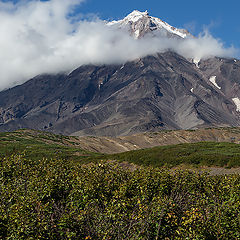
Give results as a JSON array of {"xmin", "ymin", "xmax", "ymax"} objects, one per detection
[{"xmin": 0, "ymin": 0, "xmax": 240, "ymax": 91}]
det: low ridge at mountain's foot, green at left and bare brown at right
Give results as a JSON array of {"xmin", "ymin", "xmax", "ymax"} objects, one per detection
[{"xmin": 0, "ymin": 128, "xmax": 240, "ymax": 154}]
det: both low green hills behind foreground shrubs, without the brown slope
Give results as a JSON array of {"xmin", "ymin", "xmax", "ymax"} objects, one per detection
[{"xmin": 0, "ymin": 129, "xmax": 240, "ymax": 168}]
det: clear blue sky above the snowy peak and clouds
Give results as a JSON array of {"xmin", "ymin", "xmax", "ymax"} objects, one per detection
[{"xmin": 79, "ymin": 0, "xmax": 240, "ymax": 48}]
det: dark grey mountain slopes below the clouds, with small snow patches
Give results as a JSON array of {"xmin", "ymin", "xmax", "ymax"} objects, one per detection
[{"xmin": 0, "ymin": 52, "xmax": 240, "ymax": 136}]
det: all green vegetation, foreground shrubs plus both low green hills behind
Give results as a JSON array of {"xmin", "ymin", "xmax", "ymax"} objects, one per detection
[{"xmin": 0, "ymin": 130, "xmax": 240, "ymax": 240}]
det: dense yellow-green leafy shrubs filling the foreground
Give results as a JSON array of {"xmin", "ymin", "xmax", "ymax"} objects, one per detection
[{"xmin": 0, "ymin": 155, "xmax": 240, "ymax": 240}]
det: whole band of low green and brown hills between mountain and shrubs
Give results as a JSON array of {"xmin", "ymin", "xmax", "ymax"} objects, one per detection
[{"xmin": 0, "ymin": 128, "xmax": 240, "ymax": 173}]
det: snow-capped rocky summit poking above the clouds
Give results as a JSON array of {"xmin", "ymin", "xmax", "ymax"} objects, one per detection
[{"xmin": 108, "ymin": 10, "xmax": 191, "ymax": 38}]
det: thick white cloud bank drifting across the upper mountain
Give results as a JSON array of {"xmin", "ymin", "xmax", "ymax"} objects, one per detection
[{"xmin": 0, "ymin": 0, "xmax": 235, "ymax": 90}]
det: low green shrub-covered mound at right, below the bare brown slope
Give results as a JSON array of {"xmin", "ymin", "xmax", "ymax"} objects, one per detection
[{"xmin": 105, "ymin": 142, "xmax": 240, "ymax": 167}]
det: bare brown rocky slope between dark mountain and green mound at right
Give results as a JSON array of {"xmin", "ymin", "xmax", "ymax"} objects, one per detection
[{"xmin": 73, "ymin": 128, "xmax": 240, "ymax": 154}]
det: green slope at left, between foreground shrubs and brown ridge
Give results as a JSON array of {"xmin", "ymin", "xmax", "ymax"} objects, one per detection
[{"xmin": 0, "ymin": 130, "xmax": 102, "ymax": 163}]
